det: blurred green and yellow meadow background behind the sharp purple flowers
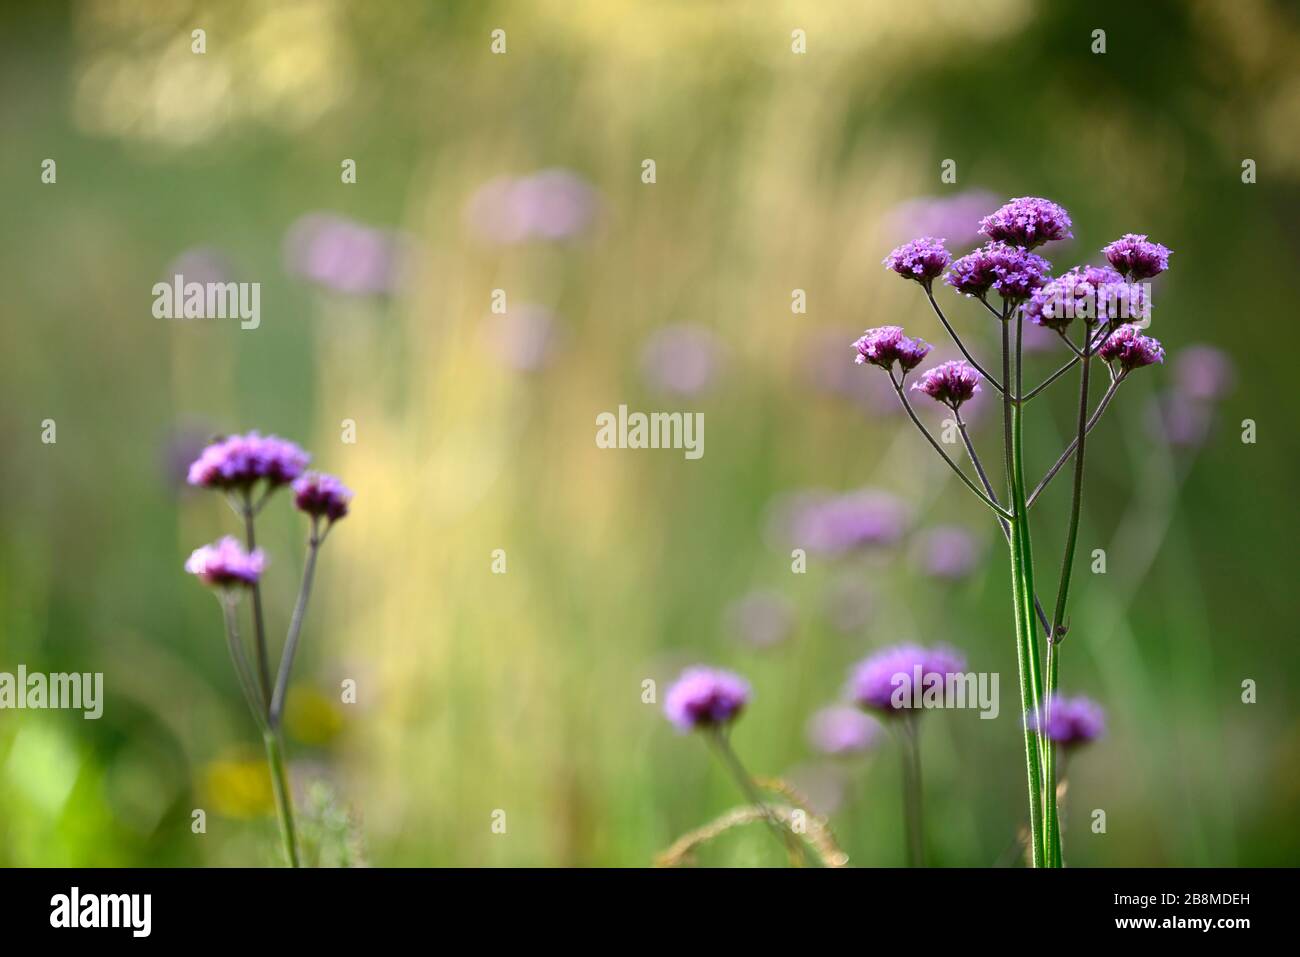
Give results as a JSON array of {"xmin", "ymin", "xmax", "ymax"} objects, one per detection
[{"xmin": 0, "ymin": 0, "xmax": 1300, "ymax": 866}]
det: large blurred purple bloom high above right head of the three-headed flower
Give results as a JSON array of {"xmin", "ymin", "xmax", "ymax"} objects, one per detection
[{"xmin": 285, "ymin": 213, "xmax": 406, "ymax": 295}]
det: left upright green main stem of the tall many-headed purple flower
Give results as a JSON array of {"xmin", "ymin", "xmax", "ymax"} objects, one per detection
[{"xmin": 1002, "ymin": 308, "xmax": 1044, "ymax": 867}]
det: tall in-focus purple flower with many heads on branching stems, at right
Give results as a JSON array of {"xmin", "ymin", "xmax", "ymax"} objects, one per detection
[{"xmin": 854, "ymin": 208, "xmax": 1170, "ymax": 867}]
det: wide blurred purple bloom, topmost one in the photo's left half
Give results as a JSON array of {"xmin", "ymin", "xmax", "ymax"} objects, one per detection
[{"xmin": 465, "ymin": 169, "xmax": 599, "ymax": 244}]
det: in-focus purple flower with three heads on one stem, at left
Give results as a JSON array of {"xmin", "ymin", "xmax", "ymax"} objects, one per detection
[{"xmin": 185, "ymin": 432, "xmax": 352, "ymax": 867}]
